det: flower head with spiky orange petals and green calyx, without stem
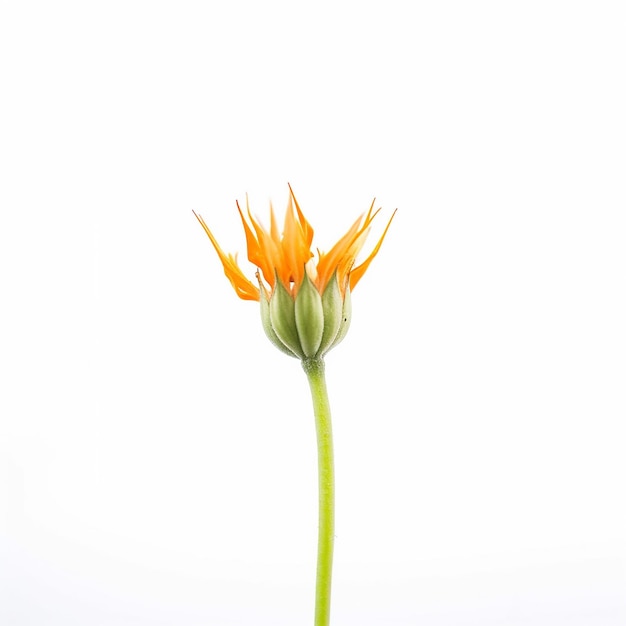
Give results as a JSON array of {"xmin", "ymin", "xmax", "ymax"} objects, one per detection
[{"xmin": 194, "ymin": 186, "xmax": 395, "ymax": 360}]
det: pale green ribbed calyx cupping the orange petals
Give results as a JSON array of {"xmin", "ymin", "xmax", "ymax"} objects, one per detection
[{"xmin": 260, "ymin": 272, "xmax": 352, "ymax": 360}]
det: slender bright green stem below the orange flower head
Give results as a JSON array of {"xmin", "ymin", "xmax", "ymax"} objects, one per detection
[{"xmin": 302, "ymin": 358, "xmax": 335, "ymax": 626}]
